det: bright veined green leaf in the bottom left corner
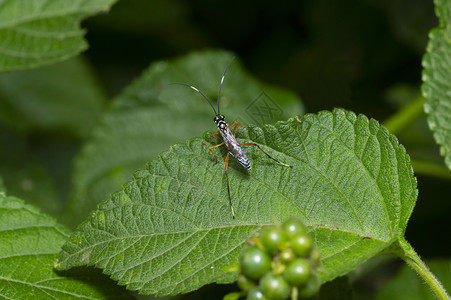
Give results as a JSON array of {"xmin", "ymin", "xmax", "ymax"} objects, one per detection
[{"xmin": 0, "ymin": 193, "xmax": 131, "ymax": 299}]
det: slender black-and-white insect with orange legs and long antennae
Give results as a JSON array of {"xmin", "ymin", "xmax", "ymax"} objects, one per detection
[{"xmin": 171, "ymin": 58, "xmax": 292, "ymax": 219}]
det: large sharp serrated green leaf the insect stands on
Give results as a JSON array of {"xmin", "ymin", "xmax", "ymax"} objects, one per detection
[{"xmin": 57, "ymin": 110, "xmax": 417, "ymax": 295}]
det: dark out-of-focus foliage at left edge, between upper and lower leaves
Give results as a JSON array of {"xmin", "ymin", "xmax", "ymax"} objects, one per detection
[{"xmin": 0, "ymin": 58, "xmax": 106, "ymax": 216}]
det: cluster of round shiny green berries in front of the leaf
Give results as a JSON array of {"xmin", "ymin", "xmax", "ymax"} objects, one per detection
[{"xmin": 238, "ymin": 218, "xmax": 320, "ymax": 300}]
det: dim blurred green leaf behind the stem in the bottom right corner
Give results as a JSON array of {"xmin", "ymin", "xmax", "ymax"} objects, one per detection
[{"xmin": 376, "ymin": 259, "xmax": 451, "ymax": 300}]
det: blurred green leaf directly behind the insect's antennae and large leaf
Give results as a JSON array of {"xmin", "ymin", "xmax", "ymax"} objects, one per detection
[{"xmin": 62, "ymin": 51, "xmax": 302, "ymax": 227}]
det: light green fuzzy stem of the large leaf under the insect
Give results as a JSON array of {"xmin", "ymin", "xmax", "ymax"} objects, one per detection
[{"xmin": 392, "ymin": 238, "xmax": 449, "ymax": 300}]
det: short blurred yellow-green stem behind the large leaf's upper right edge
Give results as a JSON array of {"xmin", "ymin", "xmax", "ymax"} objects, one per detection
[{"xmin": 383, "ymin": 96, "xmax": 424, "ymax": 134}]
